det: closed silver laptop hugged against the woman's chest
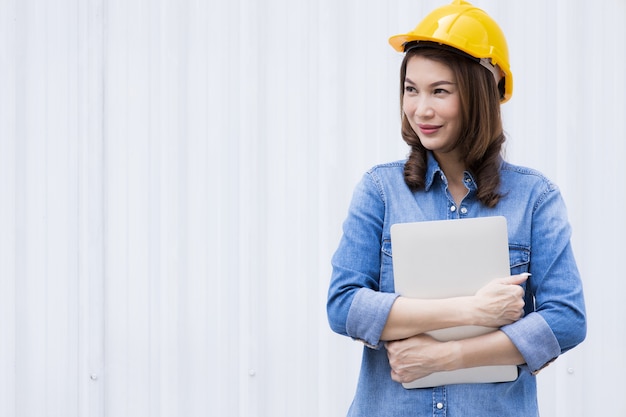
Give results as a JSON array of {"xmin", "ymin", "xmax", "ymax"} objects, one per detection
[{"xmin": 391, "ymin": 216, "xmax": 517, "ymax": 388}]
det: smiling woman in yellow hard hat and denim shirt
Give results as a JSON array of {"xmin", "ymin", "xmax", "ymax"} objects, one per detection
[{"xmin": 327, "ymin": 1, "xmax": 586, "ymax": 417}]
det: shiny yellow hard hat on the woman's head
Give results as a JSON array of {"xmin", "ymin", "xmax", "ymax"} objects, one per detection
[{"xmin": 389, "ymin": 0, "xmax": 513, "ymax": 103}]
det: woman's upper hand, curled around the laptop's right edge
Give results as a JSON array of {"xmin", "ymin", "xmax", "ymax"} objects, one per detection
[{"xmin": 474, "ymin": 273, "xmax": 530, "ymax": 328}]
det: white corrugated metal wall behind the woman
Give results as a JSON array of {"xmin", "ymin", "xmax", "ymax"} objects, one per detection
[{"xmin": 0, "ymin": 0, "xmax": 626, "ymax": 417}]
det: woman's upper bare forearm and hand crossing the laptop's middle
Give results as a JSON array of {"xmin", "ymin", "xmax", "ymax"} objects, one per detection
[{"xmin": 381, "ymin": 274, "xmax": 528, "ymax": 340}]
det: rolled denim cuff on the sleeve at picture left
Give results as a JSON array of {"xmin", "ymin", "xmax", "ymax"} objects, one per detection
[{"xmin": 346, "ymin": 288, "xmax": 399, "ymax": 349}]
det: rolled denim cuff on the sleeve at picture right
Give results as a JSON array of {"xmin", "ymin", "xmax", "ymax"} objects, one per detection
[{"xmin": 500, "ymin": 312, "xmax": 561, "ymax": 374}]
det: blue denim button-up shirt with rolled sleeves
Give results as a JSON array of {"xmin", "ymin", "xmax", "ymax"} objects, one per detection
[{"xmin": 327, "ymin": 154, "xmax": 586, "ymax": 417}]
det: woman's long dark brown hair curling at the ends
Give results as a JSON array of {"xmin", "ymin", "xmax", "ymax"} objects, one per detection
[{"xmin": 400, "ymin": 47, "xmax": 505, "ymax": 207}]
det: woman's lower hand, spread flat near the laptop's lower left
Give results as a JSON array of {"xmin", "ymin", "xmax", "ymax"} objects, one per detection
[{"xmin": 385, "ymin": 334, "xmax": 450, "ymax": 383}]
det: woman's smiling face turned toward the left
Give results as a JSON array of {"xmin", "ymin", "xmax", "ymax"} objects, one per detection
[{"xmin": 402, "ymin": 55, "xmax": 461, "ymax": 154}]
